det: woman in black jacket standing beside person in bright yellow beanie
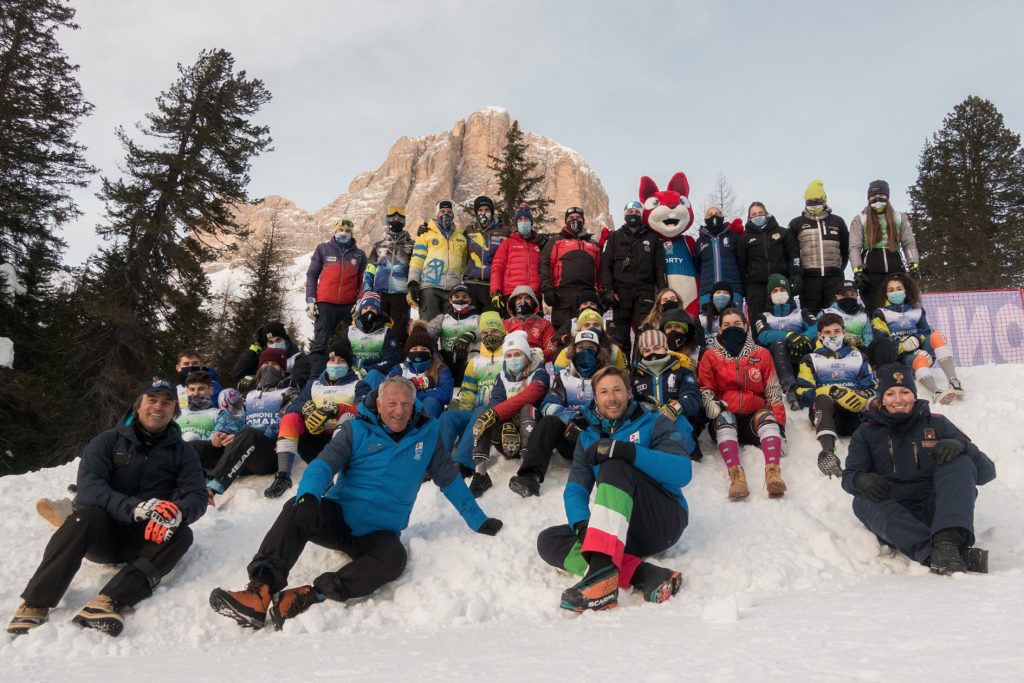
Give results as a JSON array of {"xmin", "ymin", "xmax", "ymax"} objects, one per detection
[{"xmin": 736, "ymin": 202, "xmax": 802, "ymax": 321}]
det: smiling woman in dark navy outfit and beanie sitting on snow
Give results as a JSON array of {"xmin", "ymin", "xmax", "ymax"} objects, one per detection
[{"xmin": 843, "ymin": 364, "xmax": 995, "ymax": 574}]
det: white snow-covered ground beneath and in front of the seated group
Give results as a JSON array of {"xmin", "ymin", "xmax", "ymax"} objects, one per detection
[{"xmin": 0, "ymin": 366, "xmax": 1024, "ymax": 681}]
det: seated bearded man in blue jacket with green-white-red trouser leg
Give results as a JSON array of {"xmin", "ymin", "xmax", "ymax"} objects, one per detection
[{"xmin": 537, "ymin": 368, "xmax": 692, "ymax": 612}]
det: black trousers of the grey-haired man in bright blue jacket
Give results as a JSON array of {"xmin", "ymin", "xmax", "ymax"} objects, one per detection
[{"xmin": 248, "ymin": 498, "xmax": 408, "ymax": 600}]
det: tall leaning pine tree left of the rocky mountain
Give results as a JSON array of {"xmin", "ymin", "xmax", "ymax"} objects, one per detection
[{"xmin": 53, "ymin": 49, "xmax": 270, "ymax": 464}]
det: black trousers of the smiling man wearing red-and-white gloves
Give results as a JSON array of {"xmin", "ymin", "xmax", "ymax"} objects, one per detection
[{"xmin": 22, "ymin": 505, "xmax": 193, "ymax": 607}]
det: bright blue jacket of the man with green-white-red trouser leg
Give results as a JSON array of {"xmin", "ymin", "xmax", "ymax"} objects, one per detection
[{"xmin": 562, "ymin": 402, "xmax": 693, "ymax": 526}]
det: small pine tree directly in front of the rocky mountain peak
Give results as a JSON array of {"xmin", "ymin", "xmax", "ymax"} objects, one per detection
[{"xmin": 485, "ymin": 121, "xmax": 551, "ymax": 227}]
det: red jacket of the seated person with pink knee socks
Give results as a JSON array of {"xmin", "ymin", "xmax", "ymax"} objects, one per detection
[{"xmin": 697, "ymin": 335, "xmax": 785, "ymax": 427}]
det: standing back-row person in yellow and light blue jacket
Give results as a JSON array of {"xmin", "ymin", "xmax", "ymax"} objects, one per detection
[{"xmin": 409, "ymin": 200, "xmax": 469, "ymax": 321}]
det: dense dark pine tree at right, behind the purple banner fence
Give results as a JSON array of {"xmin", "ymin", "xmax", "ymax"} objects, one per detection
[{"xmin": 909, "ymin": 96, "xmax": 1024, "ymax": 291}]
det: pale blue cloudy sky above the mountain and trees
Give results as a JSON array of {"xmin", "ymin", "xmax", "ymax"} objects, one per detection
[{"xmin": 62, "ymin": 0, "xmax": 1024, "ymax": 263}]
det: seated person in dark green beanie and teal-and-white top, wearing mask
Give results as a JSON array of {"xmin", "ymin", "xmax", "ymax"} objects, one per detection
[{"xmin": 754, "ymin": 272, "xmax": 817, "ymax": 410}]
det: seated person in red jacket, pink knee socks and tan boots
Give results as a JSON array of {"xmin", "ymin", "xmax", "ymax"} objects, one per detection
[{"xmin": 697, "ymin": 308, "xmax": 785, "ymax": 501}]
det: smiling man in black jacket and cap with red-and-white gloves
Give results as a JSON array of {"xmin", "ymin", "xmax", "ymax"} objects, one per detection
[{"xmin": 7, "ymin": 378, "xmax": 207, "ymax": 636}]
